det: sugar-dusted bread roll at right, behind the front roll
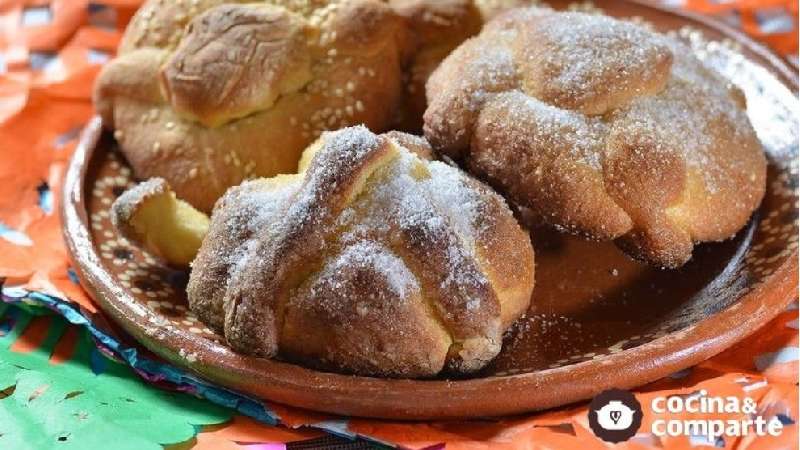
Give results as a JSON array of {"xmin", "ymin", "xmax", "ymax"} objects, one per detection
[{"xmin": 425, "ymin": 8, "xmax": 766, "ymax": 267}]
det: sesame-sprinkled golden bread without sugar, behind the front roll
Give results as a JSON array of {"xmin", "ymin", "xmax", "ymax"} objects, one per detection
[{"xmin": 95, "ymin": 0, "xmax": 410, "ymax": 212}]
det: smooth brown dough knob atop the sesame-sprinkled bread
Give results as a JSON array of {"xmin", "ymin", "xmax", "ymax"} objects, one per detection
[{"xmin": 161, "ymin": 4, "xmax": 313, "ymax": 127}]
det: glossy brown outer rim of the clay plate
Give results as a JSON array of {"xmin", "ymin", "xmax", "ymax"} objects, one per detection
[{"xmin": 61, "ymin": 1, "xmax": 798, "ymax": 420}]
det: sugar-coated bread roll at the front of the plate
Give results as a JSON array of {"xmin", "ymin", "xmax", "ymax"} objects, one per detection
[{"xmin": 187, "ymin": 127, "xmax": 534, "ymax": 377}]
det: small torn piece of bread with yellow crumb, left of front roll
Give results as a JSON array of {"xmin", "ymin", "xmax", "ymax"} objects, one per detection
[{"xmin": 111, "ymin": 178, "xmax": 209, "ymax": 266}]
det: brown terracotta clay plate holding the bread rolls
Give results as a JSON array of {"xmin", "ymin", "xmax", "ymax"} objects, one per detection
[{"xmin": 63, "ymin": 0, "xmax": 798, "ymax": 419}]
